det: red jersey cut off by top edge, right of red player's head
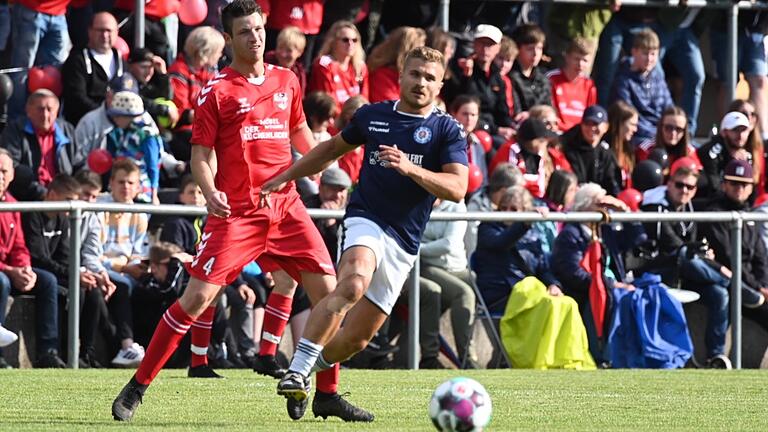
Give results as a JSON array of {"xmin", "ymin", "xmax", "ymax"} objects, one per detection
[{"xmin": 256, "ymin": 0, "xmax": 323, "ymax": 35}]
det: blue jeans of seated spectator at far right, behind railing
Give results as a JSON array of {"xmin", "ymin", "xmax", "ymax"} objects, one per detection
[{"xmin": 680, "ymin": 257, "xmax": 731, "ymax": 358}]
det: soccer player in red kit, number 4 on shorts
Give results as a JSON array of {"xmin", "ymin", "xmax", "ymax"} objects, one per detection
[{"xmin": 112, "ymin": 0, "xmax": 367, "ymax": 421}]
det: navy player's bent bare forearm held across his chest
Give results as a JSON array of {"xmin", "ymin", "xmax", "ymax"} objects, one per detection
[{"xmin": 379, "ymin": 145, "xmax": 469, "ymax": 202}]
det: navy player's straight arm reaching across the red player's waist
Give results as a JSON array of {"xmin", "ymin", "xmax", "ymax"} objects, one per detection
[{"xmin": 261, "ymin": 133, "xmax": 356, "ymax": 195}]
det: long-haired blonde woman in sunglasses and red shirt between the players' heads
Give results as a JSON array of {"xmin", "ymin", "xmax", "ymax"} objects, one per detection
[{"xmin": 308, "ymin": 20, "xmax": 368, "ymax": 109}]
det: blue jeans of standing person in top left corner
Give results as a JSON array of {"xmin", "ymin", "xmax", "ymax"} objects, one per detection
[{"xmin": 8, "ymin": 3, "xmax": 70, "ymax": 119}]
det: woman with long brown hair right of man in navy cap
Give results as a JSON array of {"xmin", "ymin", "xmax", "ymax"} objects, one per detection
[{"xmin": 604, "ymin": 100, "xmax": 639, "ymax": 189}]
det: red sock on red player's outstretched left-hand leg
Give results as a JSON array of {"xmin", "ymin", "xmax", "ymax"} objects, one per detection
[{"xmin": 135, "ymin": 300, "xmax": 192, "ymax": 385}]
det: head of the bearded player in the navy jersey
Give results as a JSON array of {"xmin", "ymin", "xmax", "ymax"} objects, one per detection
[{"xmin": 400, "ymin": 58, "xmax": 445, "ymax": 109}]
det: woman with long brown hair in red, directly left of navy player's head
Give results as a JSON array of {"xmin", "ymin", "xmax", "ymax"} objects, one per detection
[{"xmin": 368, "ymin": 27, "xmax": 427, "ymax": 102}]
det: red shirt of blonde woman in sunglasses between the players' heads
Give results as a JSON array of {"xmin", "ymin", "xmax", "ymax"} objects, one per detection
[{"xmin": 309, "ymin": 55, "xmax": 368, "ymax": 111}]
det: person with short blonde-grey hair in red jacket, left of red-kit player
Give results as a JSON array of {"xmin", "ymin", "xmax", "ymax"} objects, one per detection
[{"xmin": 168, "ymin": 27, "xmax": 224, "ymax": 162}]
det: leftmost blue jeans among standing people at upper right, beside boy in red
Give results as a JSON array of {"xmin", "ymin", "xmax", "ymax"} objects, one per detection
[{"xmin": 592, "ymin": 15, "xmax": 664, "ymax": 108}]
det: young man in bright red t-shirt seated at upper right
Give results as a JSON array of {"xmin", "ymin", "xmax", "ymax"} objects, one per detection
[{"xmin": 547, "ymin": 38, "xmax": 597, "ymax": 131}]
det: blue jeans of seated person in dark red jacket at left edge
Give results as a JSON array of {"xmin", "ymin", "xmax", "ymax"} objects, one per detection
[{"xmin": 3, "ymin": 267, "xmax": 59, "ymax": 357}]
